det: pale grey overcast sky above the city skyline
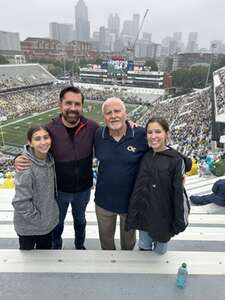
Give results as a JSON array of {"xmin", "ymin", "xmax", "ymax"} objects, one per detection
[{"xmin": 0, "ymin": 0, "xmax": 225, "ymax": 48}]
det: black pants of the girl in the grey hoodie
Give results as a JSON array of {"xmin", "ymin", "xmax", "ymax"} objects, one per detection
[{"xmin": 18, "ymin": 231, "xmax": 52, "ymax": 250}]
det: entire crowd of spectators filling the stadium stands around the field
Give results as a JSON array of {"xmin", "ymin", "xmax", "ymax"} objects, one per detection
[{"xmin": 0, "ymin": 64, "xmax": 225, "ymax": 173}]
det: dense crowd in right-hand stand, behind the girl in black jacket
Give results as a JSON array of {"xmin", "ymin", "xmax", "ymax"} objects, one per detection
[{"xmin": 135, "ymin": 88, "xmax": 211, "ymax": 156}]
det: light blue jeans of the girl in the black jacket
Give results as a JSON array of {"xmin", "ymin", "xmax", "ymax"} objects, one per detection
[{"xmin": 138, "ymin": 230, "xmax": 168, "ymax": 254}]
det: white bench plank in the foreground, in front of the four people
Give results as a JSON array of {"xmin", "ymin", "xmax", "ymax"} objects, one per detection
[{"xmin": 0, "ymin": 250, "xmax": 225, "ymax": 275}]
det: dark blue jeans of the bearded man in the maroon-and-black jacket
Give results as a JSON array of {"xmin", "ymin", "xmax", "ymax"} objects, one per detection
[{"xmin": 52, "ymin": 189, "xmax": 91, "ymax": 249}]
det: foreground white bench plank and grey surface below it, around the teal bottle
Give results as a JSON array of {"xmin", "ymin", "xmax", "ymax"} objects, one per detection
[{"xmin": 0, "ymin": 250, "xmax": 225, "ymax": 300}]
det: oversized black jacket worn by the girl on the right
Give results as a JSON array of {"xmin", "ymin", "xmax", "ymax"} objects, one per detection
[{"xmin": 126, "ymin": 148, "xmax": 189, "ymax": 242}]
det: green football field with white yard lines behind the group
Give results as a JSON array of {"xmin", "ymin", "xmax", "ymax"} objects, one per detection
[{"xmin": 0, "ymin": 102, "xmax": 134, "ymax": 146}]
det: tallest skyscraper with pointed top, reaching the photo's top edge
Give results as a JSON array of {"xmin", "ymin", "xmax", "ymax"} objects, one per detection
[{"xmin": 75, "ymin": 0, "xmax": 90, "ymax": 41}]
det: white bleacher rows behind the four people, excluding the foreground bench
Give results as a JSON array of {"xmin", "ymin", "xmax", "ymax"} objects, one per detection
[{"xmin": 0, "ymin": 176, "xmax": 225, "ymax": 251}]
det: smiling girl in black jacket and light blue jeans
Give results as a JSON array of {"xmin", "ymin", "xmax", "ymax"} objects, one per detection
[{"xmin": 126, "ymin": 117, "xmax": 189, "ymax": 254}]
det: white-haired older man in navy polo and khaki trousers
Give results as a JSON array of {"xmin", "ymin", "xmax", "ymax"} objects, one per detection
[{"xmin": 94, "ymin": 98, "xmax": 148, "ymax": 250}]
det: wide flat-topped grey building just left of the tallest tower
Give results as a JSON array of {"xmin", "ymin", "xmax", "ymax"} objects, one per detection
[{"xmin": 49, "ymin": 22, "xmax": 73, "ymax": 44}]
